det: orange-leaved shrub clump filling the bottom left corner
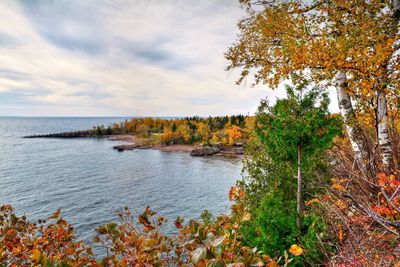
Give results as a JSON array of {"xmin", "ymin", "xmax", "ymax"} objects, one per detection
[{"xmin": 0, "ymin": 205, "xmax": 97, "ymax": 266}]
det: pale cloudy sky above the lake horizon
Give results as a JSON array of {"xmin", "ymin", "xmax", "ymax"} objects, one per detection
[{"xmin": 0, "ymin": 0, "xmax": 334, "ymax": 116}]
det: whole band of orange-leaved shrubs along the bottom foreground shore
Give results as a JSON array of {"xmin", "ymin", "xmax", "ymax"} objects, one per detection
[{"xmin": 0, "ymin": 187, "xmax": 302, "ymax": 267}]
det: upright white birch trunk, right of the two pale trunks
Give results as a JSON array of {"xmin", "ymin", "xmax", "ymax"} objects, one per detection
[{"xmin": 376, "ymin": 91, "xmax": 393, "ymax": 171}]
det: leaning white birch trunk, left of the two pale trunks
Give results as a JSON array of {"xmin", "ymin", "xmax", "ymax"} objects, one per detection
[{"xmin": 336, "ymin": 72, "xmax": 365, "ymax": 169}]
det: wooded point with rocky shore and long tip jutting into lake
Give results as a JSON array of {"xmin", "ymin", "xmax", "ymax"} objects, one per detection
[{"xmin": 24, "ymin": 115, "xmax": 250, "ymax": 156}]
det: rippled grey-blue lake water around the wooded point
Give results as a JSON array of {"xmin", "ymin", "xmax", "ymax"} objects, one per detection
[{"xmin": 0, "ymin": 117, "xmax": 242, "ymax": 245}]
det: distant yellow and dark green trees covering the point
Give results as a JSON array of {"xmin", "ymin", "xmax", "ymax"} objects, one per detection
[{"xmin": 93, "ymin": 115, "xmax": 254, "ymax": 145}]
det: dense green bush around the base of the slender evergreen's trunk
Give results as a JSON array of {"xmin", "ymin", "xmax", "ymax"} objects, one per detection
[{"xmin": 242, "ymin": 187, "xmax": 333, "ymax": 266}]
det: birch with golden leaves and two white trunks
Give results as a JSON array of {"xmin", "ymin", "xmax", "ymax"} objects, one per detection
[{"xmin": 226, "ymin": 0, "xmax": 400, "ymax": 172}]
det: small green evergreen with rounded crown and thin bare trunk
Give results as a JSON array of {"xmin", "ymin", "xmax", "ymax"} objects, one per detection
[{"xmin": 255, "ymin": 83, "xmax": 340, "ymax": 229}]
